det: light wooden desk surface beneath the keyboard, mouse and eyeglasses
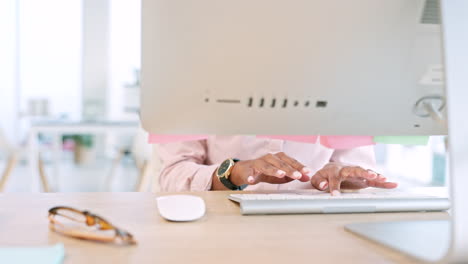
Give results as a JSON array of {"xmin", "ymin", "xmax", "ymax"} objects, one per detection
[{"xmin": 0, "ymin": 192, "xmax": 448, "ymax": 264}]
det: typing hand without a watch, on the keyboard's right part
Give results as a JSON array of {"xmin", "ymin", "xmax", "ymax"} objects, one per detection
[{"xmin": 311, "ymin": 162, "xmax": 398, "ymax": 196}]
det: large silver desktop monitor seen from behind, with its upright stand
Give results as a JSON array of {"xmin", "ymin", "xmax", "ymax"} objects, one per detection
[{"xmin": 141, "ymin": 0, "xmax": 468, "ymax": 261}]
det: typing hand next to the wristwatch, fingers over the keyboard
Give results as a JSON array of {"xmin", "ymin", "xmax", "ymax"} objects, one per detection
[{"xmin": 229, "ymin": 152, "xmax": 312, "ymax": 186}]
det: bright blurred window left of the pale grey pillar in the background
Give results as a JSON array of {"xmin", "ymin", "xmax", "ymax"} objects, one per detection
[{"xmin": 18, "ymin": 0, "xmax": 82, "ymax": 119}]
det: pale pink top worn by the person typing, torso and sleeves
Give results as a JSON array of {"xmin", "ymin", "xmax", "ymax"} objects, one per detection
[{"xmin": 158, "ymin": 136, "xmax": 375, "ymax": 191}]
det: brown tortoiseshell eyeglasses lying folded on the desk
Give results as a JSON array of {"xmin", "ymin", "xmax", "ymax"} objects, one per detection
[{"xmin": 49, "ymin": 206, "xmax": 136, "ymax": 244}]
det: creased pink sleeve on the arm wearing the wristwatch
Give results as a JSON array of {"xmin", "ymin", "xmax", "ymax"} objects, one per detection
[{"xmin": 158, "ymin": 140, "xmax": 218, "ymax": 192}]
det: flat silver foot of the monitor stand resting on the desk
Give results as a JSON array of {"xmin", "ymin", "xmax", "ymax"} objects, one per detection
[{"xmin": 345, "ymin": 220, "xmax": 451, "ymax": 262}]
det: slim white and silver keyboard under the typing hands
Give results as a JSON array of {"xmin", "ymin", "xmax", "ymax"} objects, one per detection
[{"xmin": 229, "ymin": 190, "xmax": 450, "ymax": 214}]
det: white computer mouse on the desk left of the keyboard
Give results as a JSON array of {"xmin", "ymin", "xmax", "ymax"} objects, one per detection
[{"xmin": 156, "ymin": 194, "xmax": 205, "ymax": 222}]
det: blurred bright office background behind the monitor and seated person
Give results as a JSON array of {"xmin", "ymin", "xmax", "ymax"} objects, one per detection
[{"xmin": 0, "ymin": 0, "xmax": 447, "ymax": 192}]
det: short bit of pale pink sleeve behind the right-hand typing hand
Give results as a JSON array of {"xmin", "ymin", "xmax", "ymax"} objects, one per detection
[{"xmin": 330, "ymin": 146, "xmax": 376, "ymax": 170}]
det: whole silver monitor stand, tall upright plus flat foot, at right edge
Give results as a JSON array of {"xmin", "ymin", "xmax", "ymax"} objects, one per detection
[{"xmin": 346, "ymin": 0, "xmax": 468, "ymax": 263}]
